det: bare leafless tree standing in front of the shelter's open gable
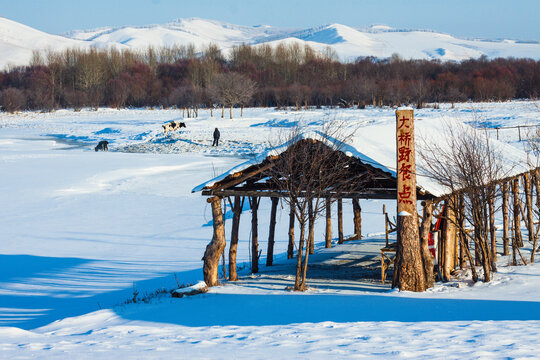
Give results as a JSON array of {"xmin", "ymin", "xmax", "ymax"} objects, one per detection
[{"xmin": 269, "ymin": 123, "xmax": 364, "ymax": 291}]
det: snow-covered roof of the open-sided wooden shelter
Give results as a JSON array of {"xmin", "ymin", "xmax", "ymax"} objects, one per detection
[{"xmin": 192, "ymin": 119, "xmax": 529, "ymax": 199}]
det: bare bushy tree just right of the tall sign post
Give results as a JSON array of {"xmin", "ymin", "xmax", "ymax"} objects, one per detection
[{"xmin": 419, "ymin": 123, "xmax": 506, "ymax": 282}]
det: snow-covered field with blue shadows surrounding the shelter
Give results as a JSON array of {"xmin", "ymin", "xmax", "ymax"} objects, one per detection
[{"xmin": 0, "ymin": 102, "xmax": 540, "ymax": 359}]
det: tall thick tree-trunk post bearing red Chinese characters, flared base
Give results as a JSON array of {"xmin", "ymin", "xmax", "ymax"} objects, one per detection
[{"xmin": 392, "ymin": 108, "xmax": 426, "ymax": 291}]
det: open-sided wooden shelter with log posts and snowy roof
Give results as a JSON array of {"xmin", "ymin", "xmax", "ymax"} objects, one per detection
[{"xmin": 193, "ymin": 122, "xmax": 540, "ymax": 286}]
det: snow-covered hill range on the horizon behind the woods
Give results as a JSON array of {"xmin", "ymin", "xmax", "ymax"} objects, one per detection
[{"xmin": 0, "ymin": 17, "xmax": 540, "ymax": 69}]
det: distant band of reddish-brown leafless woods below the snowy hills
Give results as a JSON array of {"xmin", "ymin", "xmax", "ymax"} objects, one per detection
[{"xmin": 0, "ymin": 44, "xmax": 540, "ymax": 111}]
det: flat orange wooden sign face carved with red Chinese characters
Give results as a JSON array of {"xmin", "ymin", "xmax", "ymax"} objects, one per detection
[{"xmin": 396, "ymin": 110, "xmax": 416, "ymax": 213}]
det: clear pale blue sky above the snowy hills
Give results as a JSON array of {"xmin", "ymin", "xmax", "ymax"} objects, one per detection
[{"xmin": 0, "ymin": 0, "xmax": 540, "ymax": 40}]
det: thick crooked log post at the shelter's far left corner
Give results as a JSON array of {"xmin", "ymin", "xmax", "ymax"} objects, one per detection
[{"xmin": 203, "ymin": 196, "xmax": 226, "ymax": 286}]
